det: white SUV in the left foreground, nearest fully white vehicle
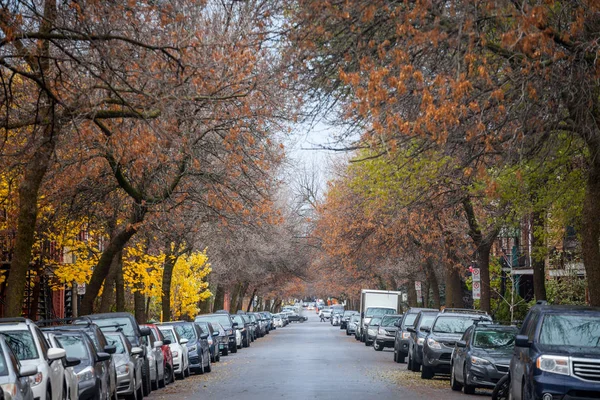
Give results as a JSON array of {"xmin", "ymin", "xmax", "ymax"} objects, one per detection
[{"xmin": 0, "ymin": 318, "xmax": 67, "ymax": 400}]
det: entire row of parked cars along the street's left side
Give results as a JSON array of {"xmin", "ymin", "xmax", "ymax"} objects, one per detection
[{"xmin": 0, "ymin": 310, "xmax": 288, "ymax": 400}]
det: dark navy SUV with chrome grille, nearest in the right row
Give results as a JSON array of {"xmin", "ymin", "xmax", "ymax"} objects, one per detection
[{"xmin": 509, "ymin": 304, "xmax": 600, "ymax": 400}]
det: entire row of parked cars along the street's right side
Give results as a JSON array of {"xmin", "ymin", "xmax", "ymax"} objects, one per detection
[{"xmin": 331, "ymin": 302, "xmax": 600, "ymax": 400}]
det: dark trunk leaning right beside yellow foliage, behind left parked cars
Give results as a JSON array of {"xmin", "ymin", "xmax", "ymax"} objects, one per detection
[{"xmin": 81, "ymin": 205, "xmax": 146, "ymax": 315}]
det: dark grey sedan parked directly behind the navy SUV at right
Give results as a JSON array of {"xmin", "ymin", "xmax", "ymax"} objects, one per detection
[{"xmin": 450, "ymin": 323, "xmax": 517, "ymax": 394}]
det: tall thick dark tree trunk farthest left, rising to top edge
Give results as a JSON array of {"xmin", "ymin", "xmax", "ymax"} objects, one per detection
[{"xmin": 4, "ymin": 0, "xmax": 57, "ymax": 317}]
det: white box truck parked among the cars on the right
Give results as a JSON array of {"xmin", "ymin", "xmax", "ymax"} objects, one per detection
[{"xmin": 358, "ymin": 289, "xmax": 402, "ymax": 342}]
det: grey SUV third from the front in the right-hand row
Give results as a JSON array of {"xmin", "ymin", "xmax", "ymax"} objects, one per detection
[{"xmin": 421, "ymin": 310, "xmax": 492, "ymax": 379}]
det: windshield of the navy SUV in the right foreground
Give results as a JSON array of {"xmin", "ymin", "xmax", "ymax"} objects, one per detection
[{"xmin": 540, "ymin": 314, "xmax": 600, "ymax": 347}]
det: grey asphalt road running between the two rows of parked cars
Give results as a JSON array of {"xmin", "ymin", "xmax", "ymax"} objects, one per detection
[{"xmin": 151, "ymin": 312, "xmax": 472, "ymax": 400}]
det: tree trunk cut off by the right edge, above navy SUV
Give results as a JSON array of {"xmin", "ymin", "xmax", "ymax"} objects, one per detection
[{"xmin": 581, "ymin": 154, "xmax": 600, "ymax": 307}]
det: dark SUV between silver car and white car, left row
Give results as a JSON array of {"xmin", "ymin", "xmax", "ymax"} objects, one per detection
[{"xmin": 81, "ymin": 312, "xmax": 152, "ymax": 396}]
